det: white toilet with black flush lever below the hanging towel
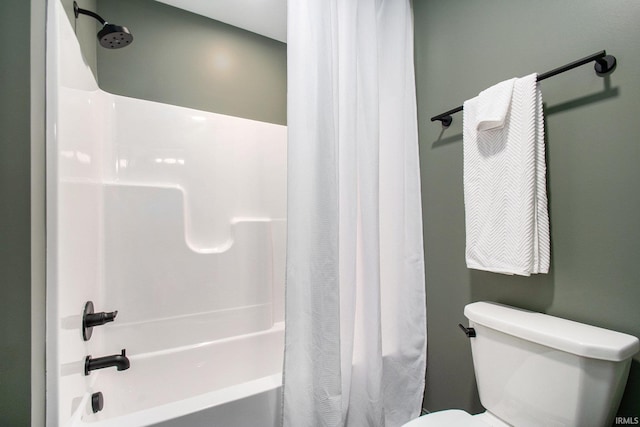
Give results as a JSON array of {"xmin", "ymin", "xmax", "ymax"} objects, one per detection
[{"xmin": 403, "ymin": 302, "xmax": 640, "ymax": 427}]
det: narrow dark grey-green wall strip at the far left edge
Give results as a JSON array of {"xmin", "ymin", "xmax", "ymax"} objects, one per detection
[{"xmin": 0, "ymin": 0, "xmax": 31, "ymax": 426}]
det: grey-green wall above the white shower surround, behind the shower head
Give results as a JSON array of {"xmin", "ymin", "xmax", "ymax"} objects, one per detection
[{"xmin": 97, "ymin": 0, "xmax": 287, "ymax": 124}]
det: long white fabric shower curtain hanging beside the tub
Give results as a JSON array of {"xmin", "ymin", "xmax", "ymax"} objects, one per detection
[{"xmin": 283, "ymin": 0, "xmax": 426, "ymax": 427}]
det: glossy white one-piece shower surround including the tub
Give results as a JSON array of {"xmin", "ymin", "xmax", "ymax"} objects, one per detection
[{"xmin": 47, "ymin": 0, "xmax": 286, "ymax": 427}]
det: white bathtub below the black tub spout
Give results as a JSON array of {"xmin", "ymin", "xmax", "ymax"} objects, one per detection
[{"xmin": 69, "ymin": 322, "xmax": 284, "ymax": 427}]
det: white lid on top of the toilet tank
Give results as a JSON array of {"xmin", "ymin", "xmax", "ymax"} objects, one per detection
[{"xmin": 464, "ymin": 302, "xmax": 640, "ymax": 362}]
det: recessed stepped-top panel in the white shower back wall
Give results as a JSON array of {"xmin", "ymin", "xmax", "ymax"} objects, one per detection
[{"xmin": 103, "ymin": 185, "xmax": 285, "ymax": 322}]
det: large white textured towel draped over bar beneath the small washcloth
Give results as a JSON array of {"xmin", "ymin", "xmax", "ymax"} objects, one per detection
[{"xmin": 463, "ymin": 74, "xmax": 550, "ymax": 276}]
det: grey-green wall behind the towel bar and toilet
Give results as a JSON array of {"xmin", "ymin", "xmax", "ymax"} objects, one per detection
[{"xmin": 414, "ymin": 0, "xmax": 640, "ymax": 422}]
